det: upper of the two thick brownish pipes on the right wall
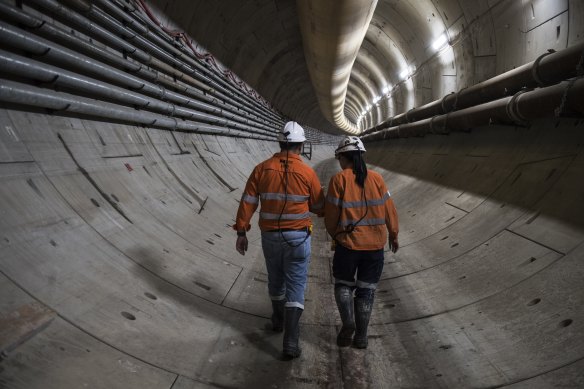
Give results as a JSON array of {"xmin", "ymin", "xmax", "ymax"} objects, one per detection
[{"xmin": 363, "ymin": 43, "xmax": 584, "ymax": 135}]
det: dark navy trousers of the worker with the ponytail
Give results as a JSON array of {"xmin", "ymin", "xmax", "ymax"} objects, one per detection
[{"xmin": 333, "ymin": 244, "xmax": 383, "ymax": 298}]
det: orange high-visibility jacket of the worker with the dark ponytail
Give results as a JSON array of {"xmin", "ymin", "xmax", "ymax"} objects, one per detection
[{"xmin": 325, "ymin": 168, "xmax": 399, "ymax": 250}]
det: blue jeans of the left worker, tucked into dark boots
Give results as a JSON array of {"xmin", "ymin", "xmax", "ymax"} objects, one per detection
[{"xmin": 262, "ymin": 231, "xmax": 311, "ymax": 309}]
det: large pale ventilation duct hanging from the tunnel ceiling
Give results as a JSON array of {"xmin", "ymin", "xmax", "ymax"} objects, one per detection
[{"xmin": 296, "ymin": 0, "xmax": 377, "ymax": 133}]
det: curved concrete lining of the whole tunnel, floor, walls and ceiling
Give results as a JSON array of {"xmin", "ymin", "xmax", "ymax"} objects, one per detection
[{"xmin": 0, "ymin": 0, "xmax": 584, "ymax": 389}]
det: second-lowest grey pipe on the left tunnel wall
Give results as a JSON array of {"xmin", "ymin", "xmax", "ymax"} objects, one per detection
[{"xmin": 0, "ymin": 50, "xmax": 273, "ymax": 135}]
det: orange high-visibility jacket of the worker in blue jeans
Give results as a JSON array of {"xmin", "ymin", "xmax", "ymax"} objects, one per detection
[{"xmin": 233, "ymin": 151, "xmax": 324, "ymax": 231}]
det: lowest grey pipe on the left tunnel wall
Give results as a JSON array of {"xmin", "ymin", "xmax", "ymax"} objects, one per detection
[{"xmin": 0, "ymin": 80, "xmax": 274, "ymax": 141}]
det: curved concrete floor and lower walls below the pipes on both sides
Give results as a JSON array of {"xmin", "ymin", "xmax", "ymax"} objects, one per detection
[{"xmin": 0, "ymin": 109, "xmax": 584, "ymax": 389}]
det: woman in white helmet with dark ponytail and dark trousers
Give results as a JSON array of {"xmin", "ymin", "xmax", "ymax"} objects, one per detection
[{"xmin": 325, "ymin": 136, "xmax": 399, "ymax": 348}]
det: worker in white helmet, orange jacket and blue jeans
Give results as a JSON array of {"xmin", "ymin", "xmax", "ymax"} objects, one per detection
[{"xmin": 234, "ymin": 122, "xmax": 324, "ymax": 359}]
